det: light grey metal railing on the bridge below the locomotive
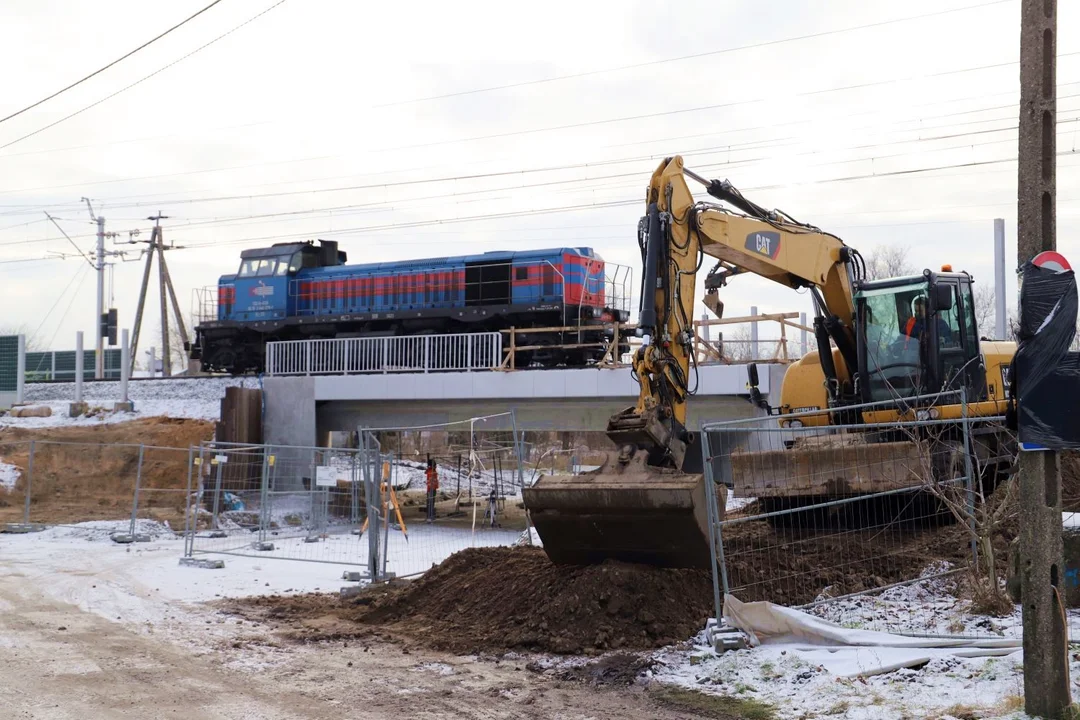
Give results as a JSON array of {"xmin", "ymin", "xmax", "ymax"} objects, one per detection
[{"xmin": 266, "ymin": 332, "xmax": 503, "ymax": 376}]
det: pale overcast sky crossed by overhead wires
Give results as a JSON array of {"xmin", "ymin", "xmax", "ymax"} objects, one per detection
[{"xmin": 0, "ymin": 0, "xmax": 1080, "ymax": 358}]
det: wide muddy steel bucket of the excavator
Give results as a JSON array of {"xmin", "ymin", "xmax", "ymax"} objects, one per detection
[{"xmin": 523, "ymin": 451, "xmax": 726, "ymax": 568}]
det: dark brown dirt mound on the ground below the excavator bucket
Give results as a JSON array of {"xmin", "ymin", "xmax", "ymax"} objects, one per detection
[{"xmin": 229, "ymin": 547, "xmax": 713, "ymax": 654}]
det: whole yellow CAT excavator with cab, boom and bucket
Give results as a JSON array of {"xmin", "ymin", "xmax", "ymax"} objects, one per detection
[{"xmin": 523, "ymin": 157, "xmax": 1015, "ymax": 567}]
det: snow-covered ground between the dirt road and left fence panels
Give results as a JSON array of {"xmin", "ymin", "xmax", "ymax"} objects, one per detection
[{"xmin": 0, "ymin": 520, "xmax": 519, "ymax": 667}]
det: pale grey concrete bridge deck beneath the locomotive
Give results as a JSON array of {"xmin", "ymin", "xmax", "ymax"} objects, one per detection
[{"xmin": 264, "ymin": 363, "xmax": 786, "ymax": 446}]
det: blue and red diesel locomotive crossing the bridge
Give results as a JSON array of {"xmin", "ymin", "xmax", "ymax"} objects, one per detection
[{"xmin": 190, "ymin": 240, "xmax": 630, "ymax": 375}]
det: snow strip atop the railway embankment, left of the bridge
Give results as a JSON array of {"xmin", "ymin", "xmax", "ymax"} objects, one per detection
[{"xmin": 0, "ymin": 378, "xmax": 259, "ymax": 427}]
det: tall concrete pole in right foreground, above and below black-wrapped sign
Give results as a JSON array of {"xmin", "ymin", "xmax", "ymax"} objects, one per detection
[{"xmin": 1016, "ymin": 0, "xmax": 1070, "ymax": 718}]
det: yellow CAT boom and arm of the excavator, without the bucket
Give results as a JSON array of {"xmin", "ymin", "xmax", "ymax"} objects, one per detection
[{"xmin": 608, "ymin": 157, "xmax": 861, "ymax": 468}]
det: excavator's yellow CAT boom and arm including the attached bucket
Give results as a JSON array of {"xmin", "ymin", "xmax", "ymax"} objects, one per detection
[{"xmin": 524, "ymin": 157, "xmax": 859, "ymax": 567}]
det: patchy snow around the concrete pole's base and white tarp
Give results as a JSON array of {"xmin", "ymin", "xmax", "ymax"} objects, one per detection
[{"xmin": 651, "ymin": 568, "xmax": 1080, "ymax": 720}]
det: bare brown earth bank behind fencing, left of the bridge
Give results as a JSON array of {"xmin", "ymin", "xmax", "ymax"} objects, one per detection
[{"xmin": 0, "ymin": 418, "xmax": 214, "ymax": 524}]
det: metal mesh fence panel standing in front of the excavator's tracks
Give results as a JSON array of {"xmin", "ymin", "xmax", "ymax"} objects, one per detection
[{"xmin": 703, "ymin": 398, "xmax": 1019, "ymax": 635}]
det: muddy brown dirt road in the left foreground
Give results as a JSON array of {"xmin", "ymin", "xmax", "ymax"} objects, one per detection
[{"xmin": 0, "ymin": 560, "xmax": 717, "ymax": 720}]
